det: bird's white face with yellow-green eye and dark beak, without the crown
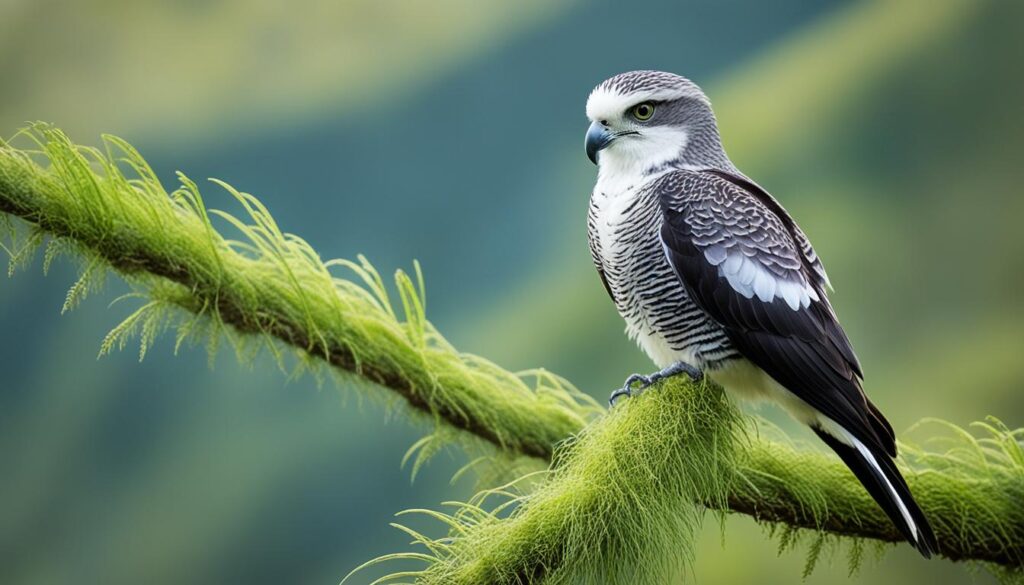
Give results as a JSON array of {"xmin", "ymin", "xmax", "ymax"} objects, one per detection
[{"xmin": 587, "ymin": 87, "xmax": 689, "ymax": 175}]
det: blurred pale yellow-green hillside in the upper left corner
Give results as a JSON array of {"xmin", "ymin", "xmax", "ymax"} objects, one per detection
[{"xmin": 0, "ymin": 0, "xmax": 570, "ymax": 141}]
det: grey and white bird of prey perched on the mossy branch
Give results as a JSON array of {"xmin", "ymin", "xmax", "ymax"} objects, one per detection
[{"xmin": 586, "ymin": 71, "xmax": 937, "ymax": 557}]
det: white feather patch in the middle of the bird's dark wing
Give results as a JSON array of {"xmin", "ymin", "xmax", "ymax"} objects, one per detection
[{"xmin": 703, "ymin": 246, "xmax": 819, "ymax": 310}]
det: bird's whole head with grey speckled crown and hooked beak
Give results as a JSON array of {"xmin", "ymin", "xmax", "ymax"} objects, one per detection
[{"xmin": 586, "ymin": 71, "xmax": 724, "ymax": 172}]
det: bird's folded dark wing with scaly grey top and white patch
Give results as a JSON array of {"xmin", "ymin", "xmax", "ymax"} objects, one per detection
[{"xmin": 652, "ymin": 171, "xmax": 895, "ymax": 454}]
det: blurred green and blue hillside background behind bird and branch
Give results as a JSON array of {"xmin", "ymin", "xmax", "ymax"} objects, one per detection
[{"xmin": 0, "ymin": 0, "xmax": 1024, "ymax": 584}]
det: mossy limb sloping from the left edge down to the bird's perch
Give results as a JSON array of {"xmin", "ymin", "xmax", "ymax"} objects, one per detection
[{"xmin": 0, "ymin": 125, "xmax": 600, "ymax": 465}]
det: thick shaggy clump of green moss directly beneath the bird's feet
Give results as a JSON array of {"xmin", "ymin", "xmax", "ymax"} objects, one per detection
[{"xmin": 348, "ymin": 377, "xmax": 740, "ymax": 585}]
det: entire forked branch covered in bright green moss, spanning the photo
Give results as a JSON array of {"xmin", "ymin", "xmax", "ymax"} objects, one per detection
[{"xmin": 0, "ymin": 126, "xmax": 1024, "ymax": 583}]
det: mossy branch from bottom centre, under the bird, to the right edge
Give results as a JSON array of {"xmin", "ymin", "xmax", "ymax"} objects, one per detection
[{"xmin": 353, "ymin": 381, "xmax": 1024, "ymax": 585}]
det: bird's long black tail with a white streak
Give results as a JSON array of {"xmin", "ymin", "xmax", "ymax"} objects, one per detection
[{"xmin": 814, "ymin": 427, "xmax": 938, "ymax": 558}]
